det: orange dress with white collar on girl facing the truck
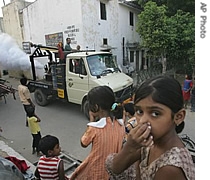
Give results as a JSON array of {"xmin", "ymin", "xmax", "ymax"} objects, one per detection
[{"xmin": 70, "ymin": 117, "xmax": 125, "ymax": 180}]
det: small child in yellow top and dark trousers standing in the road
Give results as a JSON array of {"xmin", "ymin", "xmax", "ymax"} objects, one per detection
[{"xmin": 27, "ymin": 106, "xmax": 41, "ymax": 156}]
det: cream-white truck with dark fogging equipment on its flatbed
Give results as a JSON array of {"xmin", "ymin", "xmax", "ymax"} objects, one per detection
[{"xmin": 28, "ymin": 45, "xmax": 133, "ymax": 117}]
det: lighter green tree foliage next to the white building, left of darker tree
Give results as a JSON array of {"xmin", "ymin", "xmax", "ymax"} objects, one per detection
[{"xmin": 137, "ymin": 2, "xmax": 168, "ymax": 54}]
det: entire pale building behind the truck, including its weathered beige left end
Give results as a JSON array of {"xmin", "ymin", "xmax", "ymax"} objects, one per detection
[{"xmin": 3, "ymin": 0, "xmax": 148, "ymax": 76}]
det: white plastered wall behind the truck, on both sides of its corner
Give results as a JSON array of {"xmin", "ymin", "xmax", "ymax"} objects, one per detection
[{"xmin": 23, "ymin": 0, "xmax": 140, "ymax": 65}]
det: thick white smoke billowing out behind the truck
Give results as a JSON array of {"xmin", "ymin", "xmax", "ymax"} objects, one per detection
[{"xmin": 0, "ymin": 33, "xmax": 43, "ymax": 70}]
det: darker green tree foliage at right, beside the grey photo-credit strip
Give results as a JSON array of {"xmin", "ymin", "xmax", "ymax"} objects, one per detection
[{"xmin": 167, "ymin": 10, "xmax": 195, "ymax": 72}]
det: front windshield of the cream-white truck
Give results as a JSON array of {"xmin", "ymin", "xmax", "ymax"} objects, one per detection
[{"xmin": 87, "ymin": 54, "xmax": 119, "ymax": 76}]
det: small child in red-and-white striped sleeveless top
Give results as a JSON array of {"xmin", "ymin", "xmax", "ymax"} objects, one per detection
[{"xmin": 35, "ymin": 135, "xmax": 68, "ymax": 180}]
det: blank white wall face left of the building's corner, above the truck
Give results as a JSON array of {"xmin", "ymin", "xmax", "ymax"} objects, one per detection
[{"xmin": 23, "ymin": 0, "xmax": 82, "ymax": 48}]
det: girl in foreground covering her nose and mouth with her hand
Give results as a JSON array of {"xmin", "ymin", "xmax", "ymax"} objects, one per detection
[{"xmin": 106, "ymin": 76, "xmax": 195, "ymax": 180}]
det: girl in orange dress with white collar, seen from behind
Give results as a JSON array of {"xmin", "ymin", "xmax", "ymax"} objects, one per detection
[{"xmin": 70, "ymin": 86, "xmax": 125, "ymax": 180}]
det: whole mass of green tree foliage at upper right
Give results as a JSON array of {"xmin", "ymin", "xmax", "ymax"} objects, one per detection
[{"xmin": 137, "ymin": 0, "xmax": 195, "ymax": 74}]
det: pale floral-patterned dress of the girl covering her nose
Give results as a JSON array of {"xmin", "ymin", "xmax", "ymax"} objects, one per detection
[{"xmin": 106, "ymin": 147, "xmax": 195, "ymax": 180}]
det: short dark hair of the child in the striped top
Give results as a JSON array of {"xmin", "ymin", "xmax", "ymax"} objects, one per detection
[{"xmin": 39, "ymin": 135, "xmax": 59, "ymax": 156}]
